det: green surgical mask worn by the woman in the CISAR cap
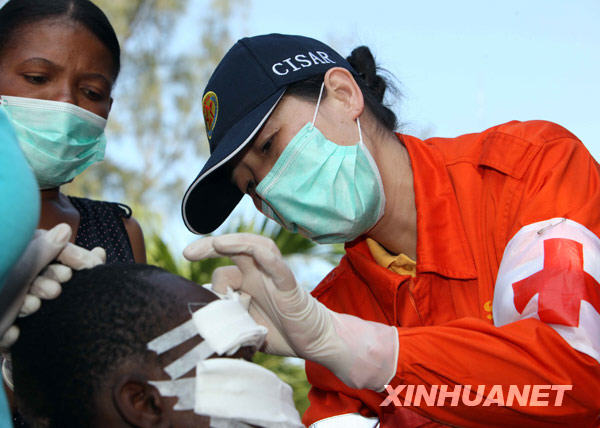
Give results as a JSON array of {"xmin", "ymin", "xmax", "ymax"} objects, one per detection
[{"xmin": 256, "ymin": 84, "xmax": 385, "ymax": 244}]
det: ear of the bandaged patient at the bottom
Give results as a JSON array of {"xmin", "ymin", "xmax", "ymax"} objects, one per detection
[{"xmin": 113, "ymin": 375, "xmax": 168, "ymax": 428}]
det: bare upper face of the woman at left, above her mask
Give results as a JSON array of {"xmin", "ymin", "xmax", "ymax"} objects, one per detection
[{"xmin": 0, "ymin": 17, "xmax": 116, "ymax": 118}]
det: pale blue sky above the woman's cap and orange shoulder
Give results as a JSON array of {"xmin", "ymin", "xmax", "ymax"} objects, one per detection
[{"xmin": 165, "ymin": 0, "xmax": 600, "ymax": 288}]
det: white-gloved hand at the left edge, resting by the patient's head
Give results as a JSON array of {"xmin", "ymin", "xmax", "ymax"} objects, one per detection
[{"xmin": 0, "ymin": 223, "xmax": 106, "ymax": 348}]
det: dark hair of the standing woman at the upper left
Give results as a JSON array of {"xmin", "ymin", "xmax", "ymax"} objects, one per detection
[{"xmin": 0, "ymin": 0, "xmax": 121, "ymax": 79}]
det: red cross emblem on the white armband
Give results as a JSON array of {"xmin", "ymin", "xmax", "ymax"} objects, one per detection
[{"xmin": 513, "ymin": 238, "xmax": 600, "ymax": 327}]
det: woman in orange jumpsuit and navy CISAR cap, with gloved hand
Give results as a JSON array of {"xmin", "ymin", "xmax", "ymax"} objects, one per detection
[{"xmin": 183, "ymin": 34, "xmax": 600, "ymax": 427}]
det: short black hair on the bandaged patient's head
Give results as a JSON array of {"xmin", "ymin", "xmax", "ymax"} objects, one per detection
[{"xmin": 11, "ymin": 264, "xmax": 186, "ymax": 428}]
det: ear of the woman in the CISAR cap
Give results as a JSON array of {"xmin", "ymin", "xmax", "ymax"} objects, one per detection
[{"xmin": 324, "ymin": 67, "xmax": 365, "ymax": 120}]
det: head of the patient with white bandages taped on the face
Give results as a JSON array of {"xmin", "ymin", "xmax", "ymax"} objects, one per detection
[{"xmin": 12, "ymin": 264, "xmax": 302, "ymax": 428}]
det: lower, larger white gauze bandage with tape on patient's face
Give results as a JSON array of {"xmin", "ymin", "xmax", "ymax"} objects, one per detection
[{"xmin": 150, "ymin": 358, "xmax": 302, "ymax": 428}]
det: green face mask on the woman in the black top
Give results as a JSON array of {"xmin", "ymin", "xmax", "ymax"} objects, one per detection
[{"xmin": 0, "ymin": 95, "xmax": 106, "ymax": 189}]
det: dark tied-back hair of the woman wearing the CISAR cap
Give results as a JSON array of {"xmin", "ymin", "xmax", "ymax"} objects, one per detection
[{"xmin": 286, "ymin": 46, "xmax": 398, "ymax": 131}]
